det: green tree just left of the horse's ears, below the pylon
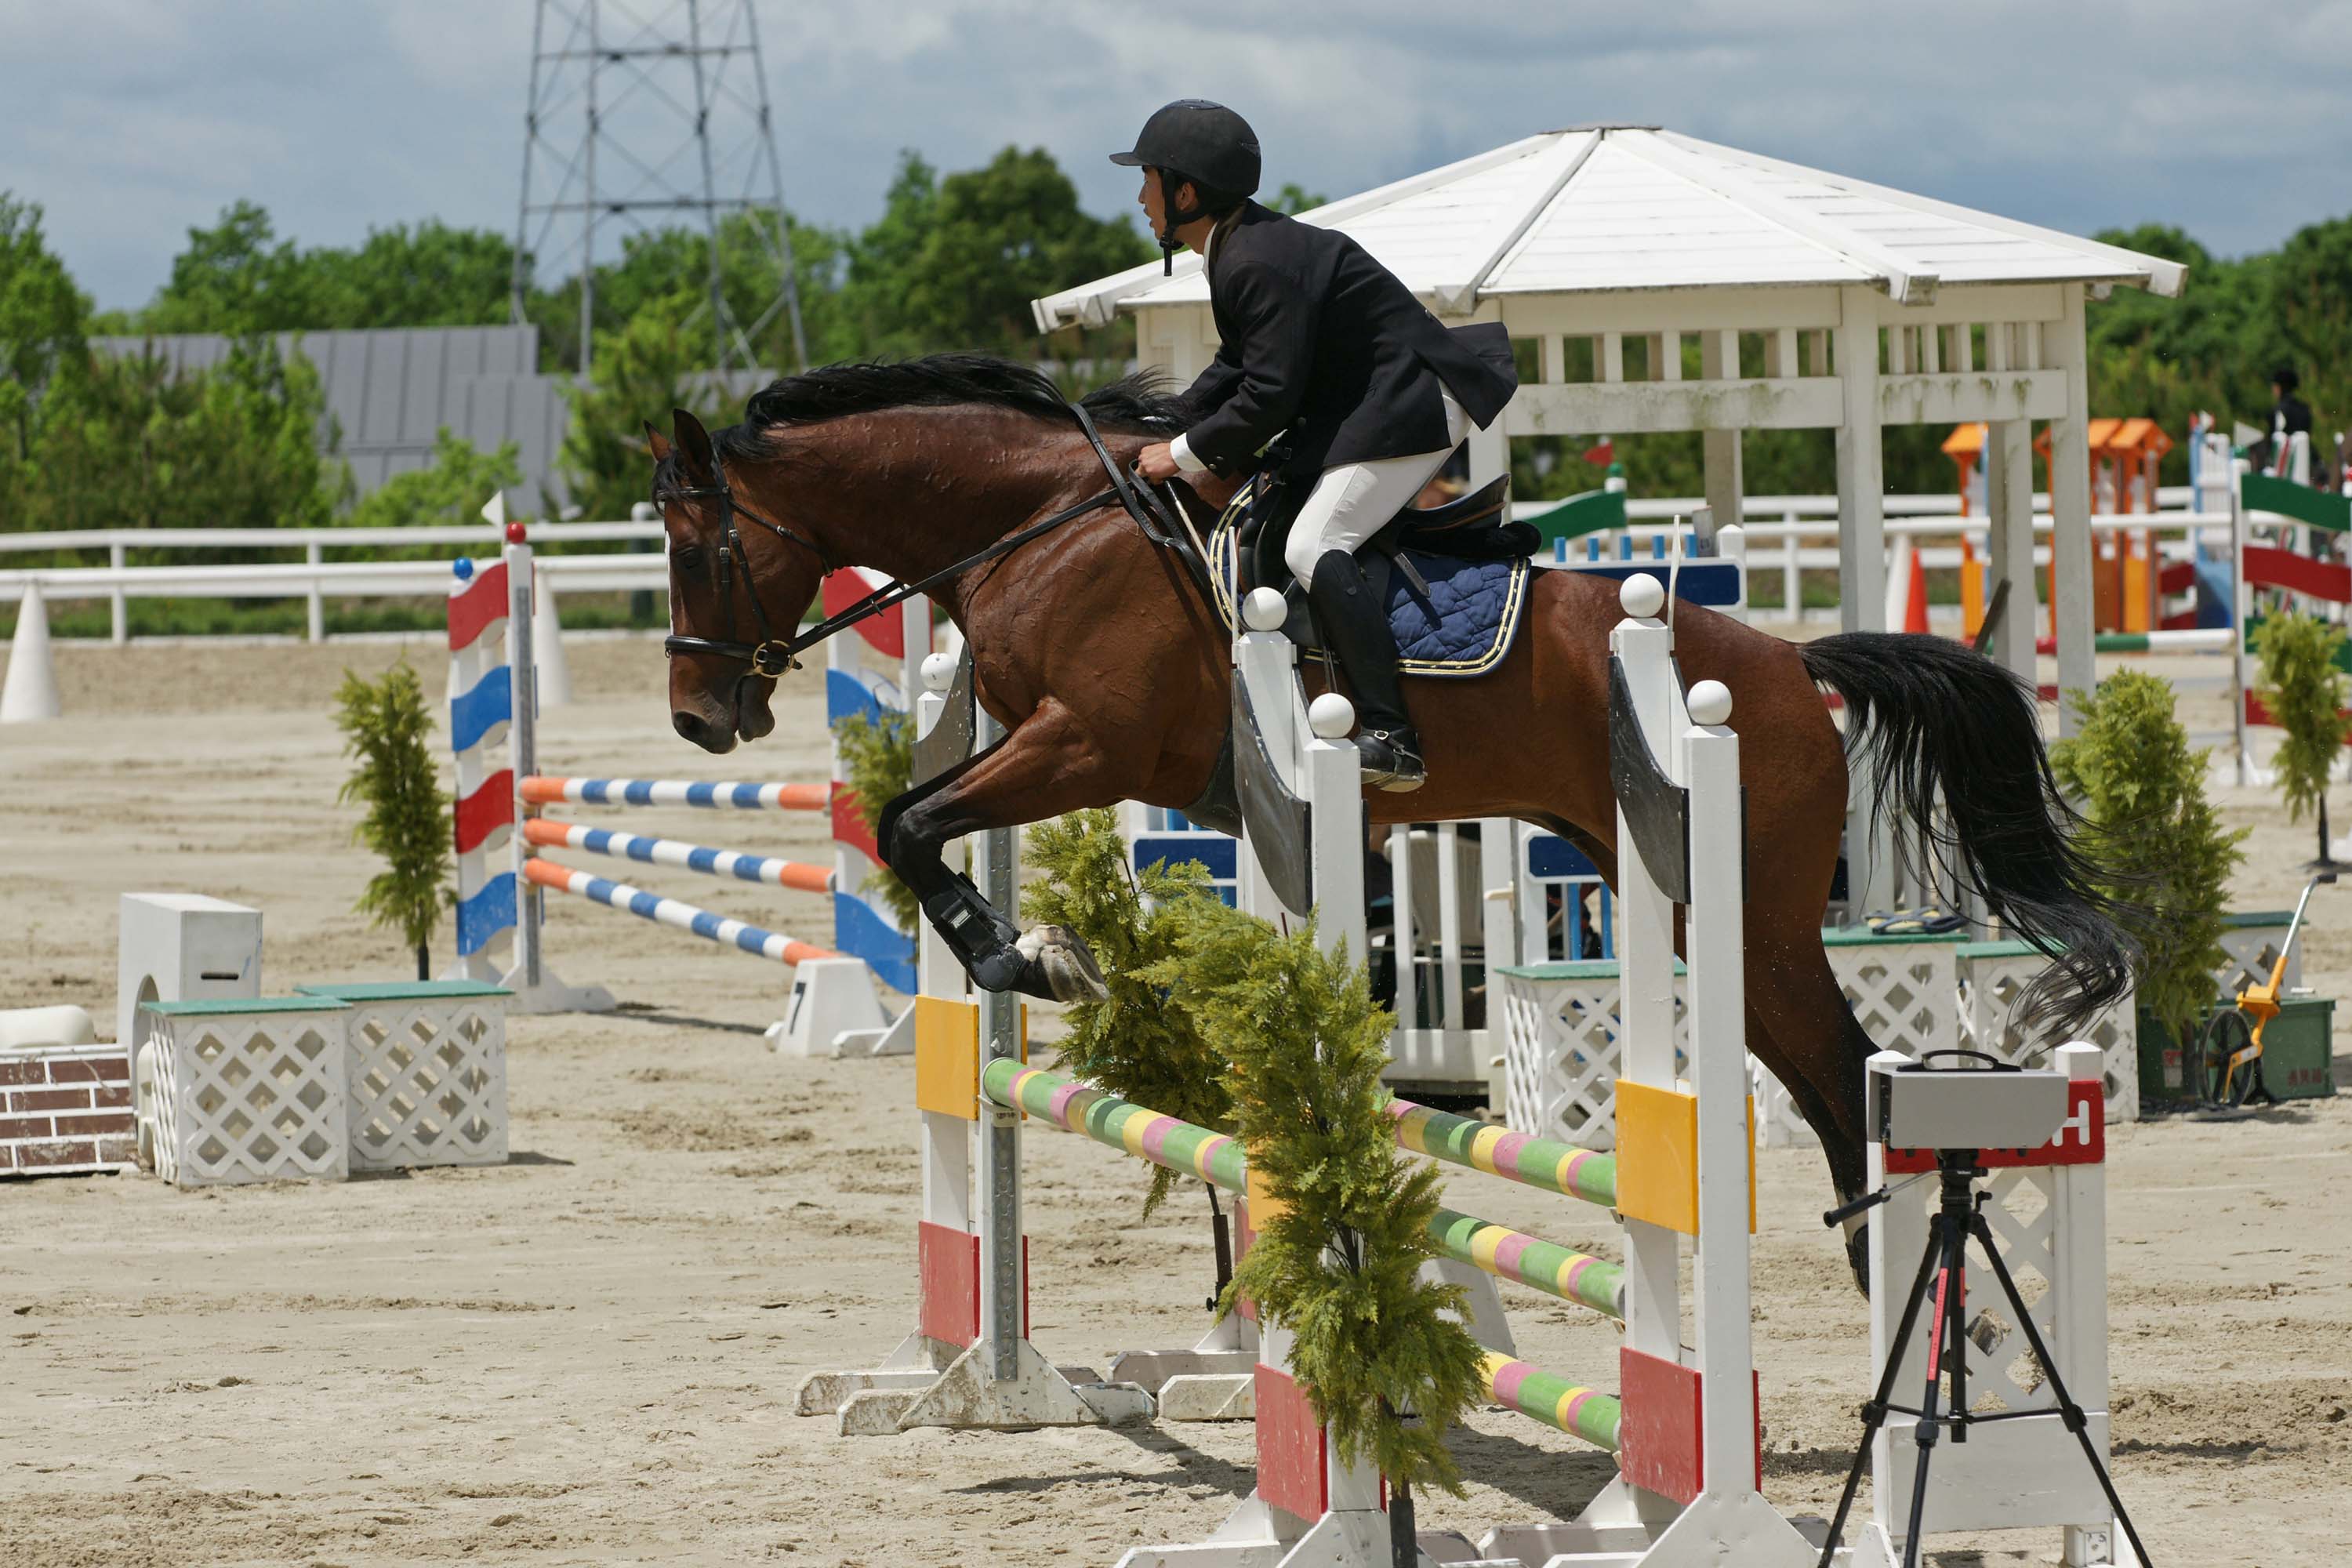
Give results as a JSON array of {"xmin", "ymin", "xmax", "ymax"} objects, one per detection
[{"xmin": 557, "ymin": 289, "xmax": 731, "ymax": 517}]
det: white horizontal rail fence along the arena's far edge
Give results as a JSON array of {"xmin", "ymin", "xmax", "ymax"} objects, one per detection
[{"xmin": 0, "ymin": 485, "xmax": 2258, "ymax": 642}]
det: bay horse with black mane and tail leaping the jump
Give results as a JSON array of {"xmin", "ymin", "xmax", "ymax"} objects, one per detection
[{"xmin": 647, "ymin": 355, "xmax": 2133, "ymax": 1199}]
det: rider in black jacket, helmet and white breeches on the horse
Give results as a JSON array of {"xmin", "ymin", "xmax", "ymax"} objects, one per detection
[{"xmin": 1110, "ymin": 99, "xmax": 1519, "ymax": 789}]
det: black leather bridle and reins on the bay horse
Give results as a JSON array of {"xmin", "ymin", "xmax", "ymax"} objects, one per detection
[{"xmin": 661, "ymin": 400, "xmax": 1209, "ymax": 680}]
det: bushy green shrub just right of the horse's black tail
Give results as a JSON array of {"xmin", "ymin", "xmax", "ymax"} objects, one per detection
[{"xmin": 2051, "ymin": 670, "xmax": 2246, "ymax": 1098}]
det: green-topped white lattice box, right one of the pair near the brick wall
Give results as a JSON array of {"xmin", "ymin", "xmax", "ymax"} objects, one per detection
[{"xmin": 294, "ymin": 980, "xmax": 508, "ymax": 1171}]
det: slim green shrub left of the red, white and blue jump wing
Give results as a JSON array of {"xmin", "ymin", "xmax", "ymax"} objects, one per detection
[{"xmin": 336, "ymin": 661, "xmax": 449, "ymax": 980}]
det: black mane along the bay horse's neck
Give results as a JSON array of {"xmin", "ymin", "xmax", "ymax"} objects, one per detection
[{"xmin": 713, "ymin": 353, "xmax": 1185, "ymax": 459}]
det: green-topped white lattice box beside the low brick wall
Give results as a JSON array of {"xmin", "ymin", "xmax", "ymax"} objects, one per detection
[{"xmin": 132, "ymin": 996, "xmax": 350, "ymax": 1187}]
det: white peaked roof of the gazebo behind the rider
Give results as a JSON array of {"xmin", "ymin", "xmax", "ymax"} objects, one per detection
[{"xmin": 1033, "ymin": 125, "xmax": 2185, "ymax": 332}]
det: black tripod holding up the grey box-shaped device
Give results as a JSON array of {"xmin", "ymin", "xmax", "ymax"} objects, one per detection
[{"xmin": 1820, "ymin": 1149, "xmax": 2147, "ymax": 1568}]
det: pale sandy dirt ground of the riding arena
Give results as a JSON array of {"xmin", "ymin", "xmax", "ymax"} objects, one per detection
[{"xmin": 0, "ymin": 640, "xmax": 2352, "ymax": 1568}]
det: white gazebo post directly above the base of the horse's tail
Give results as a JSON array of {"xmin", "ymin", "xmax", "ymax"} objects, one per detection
[{"xmin": 1830, "ymin": 285, "xmax": 1896, "ymax": 916}]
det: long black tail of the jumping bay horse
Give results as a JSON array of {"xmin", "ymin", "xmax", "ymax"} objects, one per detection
[{"xmin": 1799, "ymin": 633, "xmax": 2140, "ymax": 1034}]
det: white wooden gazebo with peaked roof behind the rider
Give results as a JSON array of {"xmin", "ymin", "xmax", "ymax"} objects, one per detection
[{"xmin": 1035, "ymin": 125, "xmax": 2185, "ymax": 907}]
